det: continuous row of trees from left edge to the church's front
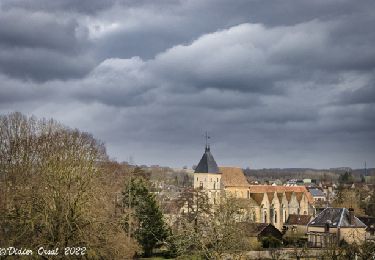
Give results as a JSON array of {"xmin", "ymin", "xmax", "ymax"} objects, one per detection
[{"xmin": 0, "ymin": 112, "xmax": 256, "ymax": 259}]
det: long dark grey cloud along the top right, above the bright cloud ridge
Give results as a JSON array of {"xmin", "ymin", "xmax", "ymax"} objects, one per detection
[{"xmin": 92, "ymin": 0, "xmax": 375, "ymax": 58}]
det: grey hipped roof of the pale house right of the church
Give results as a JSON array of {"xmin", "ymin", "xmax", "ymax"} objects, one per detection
[{"xmin": 308, "ymin": 208, "xmax": 366, "ymax": 228}]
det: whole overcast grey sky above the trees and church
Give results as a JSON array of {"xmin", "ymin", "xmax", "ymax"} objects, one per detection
[{"xmin": 0, "ymin": 0, "xmax": 375, "ymax": 168}]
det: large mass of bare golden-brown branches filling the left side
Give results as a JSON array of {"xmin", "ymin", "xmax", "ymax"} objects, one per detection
[{"xmin": 0, "ymin": 113, "xmax": 136, "ymax": 257}]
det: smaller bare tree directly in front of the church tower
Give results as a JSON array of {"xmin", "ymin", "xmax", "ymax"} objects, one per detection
[{"xmin": 173, "ymin": 195, "xmax": 251, "ymax": 259}]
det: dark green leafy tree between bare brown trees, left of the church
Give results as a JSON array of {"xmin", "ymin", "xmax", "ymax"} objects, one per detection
[{"xmin": 123, "ymin": 176, "xmax": 169, "ymax": 256}]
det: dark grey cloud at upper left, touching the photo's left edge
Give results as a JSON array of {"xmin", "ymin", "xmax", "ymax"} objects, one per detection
[{"xmin": 0, "ymin": 6, "xmax": 96, "ymax": 82}]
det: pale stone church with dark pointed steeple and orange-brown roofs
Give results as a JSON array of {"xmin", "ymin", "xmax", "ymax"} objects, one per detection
[{"xmin": 193, "ymin": 144, "xmax": 315, "ymax": 230}]
